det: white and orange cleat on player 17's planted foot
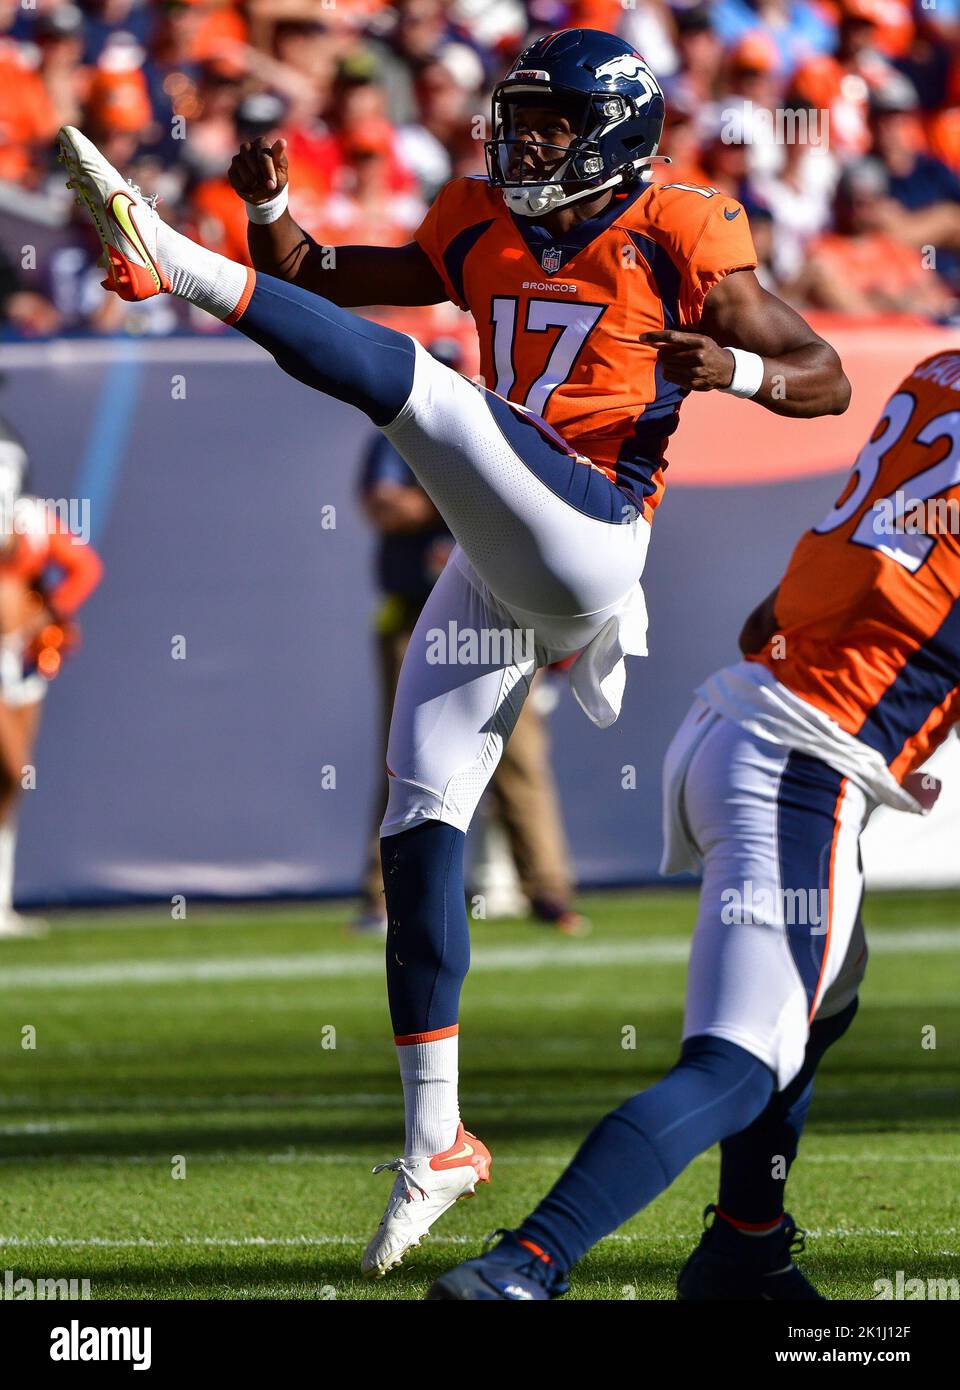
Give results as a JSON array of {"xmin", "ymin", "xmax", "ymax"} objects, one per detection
[{"xmin": 360, "ymin": 1125, "xmax": 490, "ymax": 1279}]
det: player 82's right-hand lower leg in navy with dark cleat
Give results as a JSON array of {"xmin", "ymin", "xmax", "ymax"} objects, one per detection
[{"xmin": 677, "ymin": 998, "xmax": 857, "ymax": 1302}]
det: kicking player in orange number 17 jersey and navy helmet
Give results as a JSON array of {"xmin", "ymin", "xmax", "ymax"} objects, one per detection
[{"xmin": 61, "ymin": 29, "xmax": 849, "ymax": 1275}]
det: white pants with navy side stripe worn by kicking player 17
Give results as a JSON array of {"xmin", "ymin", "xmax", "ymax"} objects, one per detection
[{"xmin": 381, "ymin": 349, "xmax": 650, "ymax": 835}]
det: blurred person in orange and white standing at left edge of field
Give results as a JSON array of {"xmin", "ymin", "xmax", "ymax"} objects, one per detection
[{"xmin": 0, "ymin": 420, "xmax": 101, "ymax": 940}]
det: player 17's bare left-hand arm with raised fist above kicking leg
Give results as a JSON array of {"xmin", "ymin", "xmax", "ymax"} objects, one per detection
[{"xmin": 228, "ymin": 139, "xmax": 447, "ymax": 309}]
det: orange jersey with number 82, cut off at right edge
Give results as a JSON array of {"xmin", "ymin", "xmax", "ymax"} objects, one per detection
[{"xmin": 750, "ymin": 352, "xmax": 960, "ymax": 781}]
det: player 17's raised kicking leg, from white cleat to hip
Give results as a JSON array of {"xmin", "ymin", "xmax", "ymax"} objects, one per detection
[{"xmin": 60, "ymin": 126, "xmax": 649, "ymax": 667}]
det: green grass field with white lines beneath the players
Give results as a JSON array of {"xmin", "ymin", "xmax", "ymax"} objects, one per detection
[{"xmin": 0, "ymin": 892, "xmax": 960, "ymax": 1300}]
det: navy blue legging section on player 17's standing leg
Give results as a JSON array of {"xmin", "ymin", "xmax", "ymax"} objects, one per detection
[{"xmin": 381, "ymin": 820, "xmax": 470, "ymax": 1038}]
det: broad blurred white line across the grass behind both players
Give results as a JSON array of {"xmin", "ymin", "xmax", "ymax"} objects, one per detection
[{"xmin": 0, "ymin": 927, "xmax": 960, "ymax": 992}]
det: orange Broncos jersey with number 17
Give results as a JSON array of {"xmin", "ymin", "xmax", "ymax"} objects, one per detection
[{"xmin": 417, "ymin": 178, "xmax": 757, "ymax": 520}]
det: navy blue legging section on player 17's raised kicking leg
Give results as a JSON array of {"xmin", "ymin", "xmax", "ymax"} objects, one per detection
[{"xmin": 236, "ymin": 274, "xmax": 415, "ymax": 425}]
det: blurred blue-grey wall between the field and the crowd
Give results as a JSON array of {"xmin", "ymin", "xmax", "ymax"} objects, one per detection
[{"xmin": 0, "ymin": 339, "xmax": 900, "ymax": 904}]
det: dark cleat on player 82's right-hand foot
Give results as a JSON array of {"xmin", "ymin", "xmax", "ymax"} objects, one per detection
[{"xmin": 677, "ymin": 1205, "xmax": 825, "ymax": 1302}]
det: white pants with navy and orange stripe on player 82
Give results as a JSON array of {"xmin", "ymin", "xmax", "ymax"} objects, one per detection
[{"xmin": 664, "ymin": 701, "xmax": 871, "ymax": 1090}]
